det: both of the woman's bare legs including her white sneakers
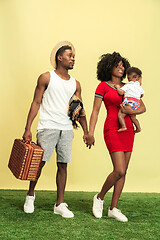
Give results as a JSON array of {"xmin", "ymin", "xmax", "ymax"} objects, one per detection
[{"xmin": 92, "ymin": 152, "xmax": 131, "ymax": 222}]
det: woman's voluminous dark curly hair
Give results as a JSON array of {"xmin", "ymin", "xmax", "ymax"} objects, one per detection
[{"xmin": 97, "ymin": 52, "xmax": 130, "ymax": 82}]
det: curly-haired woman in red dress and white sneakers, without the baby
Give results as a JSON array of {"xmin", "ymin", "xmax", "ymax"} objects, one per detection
[{"xmin": 87, "ymin": 52, "xmax": 145, "ymax": 222}]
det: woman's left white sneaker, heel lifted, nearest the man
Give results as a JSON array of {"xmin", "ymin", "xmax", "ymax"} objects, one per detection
[{"xmin": 92, "ymin": 193, "xmax": 104, "ymax": 218}]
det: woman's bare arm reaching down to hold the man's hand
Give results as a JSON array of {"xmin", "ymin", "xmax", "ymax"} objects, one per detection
[{"xmin": 87, "ymin": 97, "xmax": 102, "ymax": 149}]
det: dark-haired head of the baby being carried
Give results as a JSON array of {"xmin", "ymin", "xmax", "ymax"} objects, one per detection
[{"xmin": 126, "ymin": 67, "xmax": 142, "ymax": 82}]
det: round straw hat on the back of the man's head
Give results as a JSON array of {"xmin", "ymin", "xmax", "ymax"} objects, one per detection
[{"xmin": 50, "ymin": 41, "xmax": 75, "ymax": 68}]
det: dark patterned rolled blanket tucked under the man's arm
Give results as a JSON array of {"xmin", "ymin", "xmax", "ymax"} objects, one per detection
[{"xmin": 68, "ymin": 94, "xmax": 86, "ymax": 128}]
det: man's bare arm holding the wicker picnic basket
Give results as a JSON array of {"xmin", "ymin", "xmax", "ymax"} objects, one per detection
[{"xmin": 23, "ymin": 72, "xmax": 50, "ymax": 141}]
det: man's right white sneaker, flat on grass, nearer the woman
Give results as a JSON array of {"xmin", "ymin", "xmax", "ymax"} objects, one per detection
[{"xmin": 54, "ymin": 203, "xmax": 74, "ymax": 218}]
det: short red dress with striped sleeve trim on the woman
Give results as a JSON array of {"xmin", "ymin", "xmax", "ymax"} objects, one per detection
[{"xmin": 95, "ymin": 82, "xmax": 134, "ymax": 153}]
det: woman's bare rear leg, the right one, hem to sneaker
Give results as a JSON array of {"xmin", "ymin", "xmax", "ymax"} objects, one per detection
[{"xmin": 110, "ymin": 152, "xmax": 131, "ymax": 209}]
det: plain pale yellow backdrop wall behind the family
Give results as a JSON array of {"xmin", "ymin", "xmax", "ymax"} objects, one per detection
[{"xmin": 0, "ymin": 0, "xmax": 160, "ymax": 192}]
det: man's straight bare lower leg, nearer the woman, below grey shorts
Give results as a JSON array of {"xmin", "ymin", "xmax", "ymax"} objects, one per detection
[{"xmin": 56, "ymin": 162, "xmax": 67, "ymax": 206}]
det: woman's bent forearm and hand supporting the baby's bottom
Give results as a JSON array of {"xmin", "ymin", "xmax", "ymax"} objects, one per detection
[{"xmin": 121, "ymin": 99, "xmax": 146, "ymax": 115}]
